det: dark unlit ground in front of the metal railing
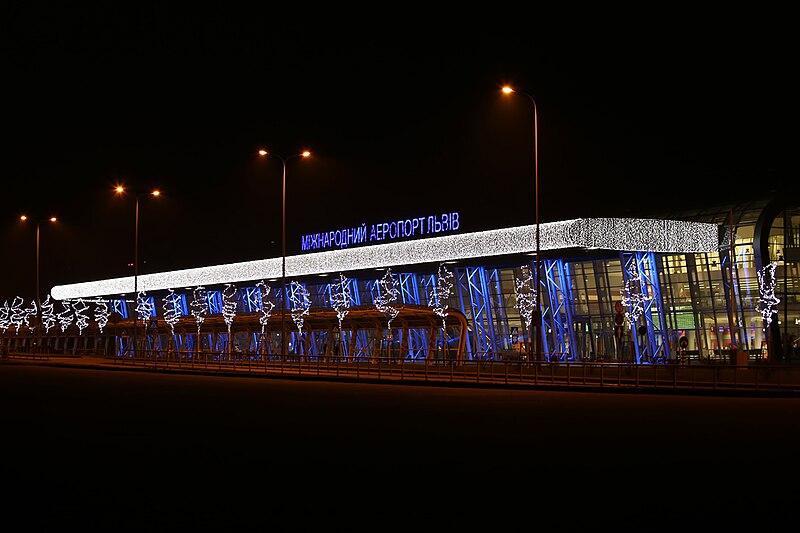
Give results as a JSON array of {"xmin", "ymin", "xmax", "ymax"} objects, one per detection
[{"xmin": 0, "ymin": 364, "xmax": 800, "ymax": 531}]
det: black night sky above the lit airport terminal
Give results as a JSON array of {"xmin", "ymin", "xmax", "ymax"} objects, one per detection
[{"xmin": 0, "ymin": 5, "xmax": 797, "ymax": 303}]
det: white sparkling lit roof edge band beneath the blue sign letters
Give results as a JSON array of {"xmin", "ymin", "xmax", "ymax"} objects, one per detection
[{"xmin": 50, "ymin": 218, "xmax": 719, "ymax": 300}]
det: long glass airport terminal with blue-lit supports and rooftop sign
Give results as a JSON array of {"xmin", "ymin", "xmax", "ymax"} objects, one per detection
[{"xmin": 0, "ymin": 193, "xmax": 800, "ymax": 363}]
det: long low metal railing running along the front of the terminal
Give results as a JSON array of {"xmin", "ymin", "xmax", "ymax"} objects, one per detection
[{"xmin": 7, "ymin": 351, "xmax": 800, "ymax": 394}]
